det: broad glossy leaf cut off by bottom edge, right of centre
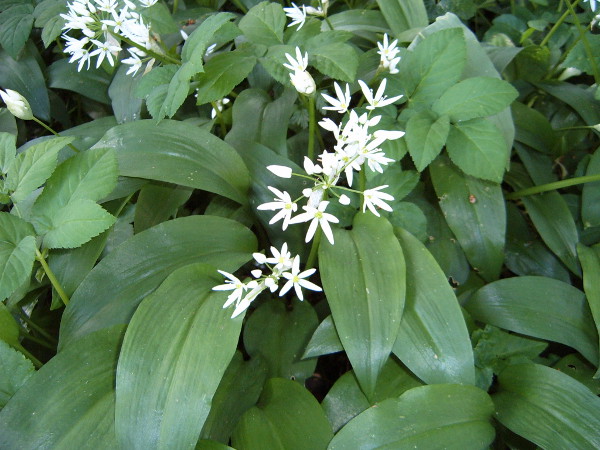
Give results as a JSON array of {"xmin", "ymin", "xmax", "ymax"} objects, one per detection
[{"xmin": 328, "ymin": 384, "xmax": 495, "ymax": 450}]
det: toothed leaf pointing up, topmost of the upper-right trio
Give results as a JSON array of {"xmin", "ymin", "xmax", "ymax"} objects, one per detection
[{"xmin": 398, "ymin": 28, "xmax": 467, "ymax": 105}]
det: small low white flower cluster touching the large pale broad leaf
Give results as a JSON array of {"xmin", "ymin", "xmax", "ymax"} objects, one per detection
[{"xmin": 213, "ymin": 243, "xmax": 321, "ymax": 319}]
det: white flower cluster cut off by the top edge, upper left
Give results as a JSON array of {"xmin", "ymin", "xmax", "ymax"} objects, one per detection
[{"xmin": 61, "ymin": 0, "xmax": 158, "ymax": 75}]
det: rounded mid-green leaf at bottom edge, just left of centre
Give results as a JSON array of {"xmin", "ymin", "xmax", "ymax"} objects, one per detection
[{"xmin": 231, "ymin": 378, "xmax": 333, "ymax": 450}]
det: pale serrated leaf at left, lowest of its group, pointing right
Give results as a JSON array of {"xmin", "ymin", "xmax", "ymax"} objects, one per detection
[{"xmin": 37, "ymin": 199, "xmax": 116, "ymax": 248}]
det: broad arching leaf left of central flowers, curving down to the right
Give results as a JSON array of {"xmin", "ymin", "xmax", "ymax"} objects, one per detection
[{"xmin": 94, "ymin": 120, "xmax": 250, "ymax": 204}]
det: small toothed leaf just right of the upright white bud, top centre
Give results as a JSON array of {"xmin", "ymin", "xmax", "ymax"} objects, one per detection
[{"xmin": 309, "ymin": 42, "xmax": 358, "ymax": 83}]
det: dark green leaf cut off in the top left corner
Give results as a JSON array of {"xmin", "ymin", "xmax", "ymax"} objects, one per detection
[{"xmin": 0, "ymin": 2, "xmax": 34, "ymax": 59}]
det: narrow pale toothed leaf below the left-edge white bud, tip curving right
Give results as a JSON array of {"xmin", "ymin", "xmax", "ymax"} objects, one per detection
[{"xmin": 5, "ymin": 137, "xmax": 74, "ymax": 203}]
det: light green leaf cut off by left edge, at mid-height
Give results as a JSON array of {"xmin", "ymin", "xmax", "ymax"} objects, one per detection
[{"xmin": 0, "ymin": 212, "xmax": 37, "ymax": 301}]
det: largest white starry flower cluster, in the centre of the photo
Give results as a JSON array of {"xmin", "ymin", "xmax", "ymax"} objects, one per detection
[{"xmin": 258, "ymin": 79, "xmax": 404, "ymax": 244}]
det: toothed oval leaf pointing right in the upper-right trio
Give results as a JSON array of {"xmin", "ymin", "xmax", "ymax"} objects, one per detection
[{"xmin": 432, "ymin": 77, "xmax": 518, "ymax": 122}]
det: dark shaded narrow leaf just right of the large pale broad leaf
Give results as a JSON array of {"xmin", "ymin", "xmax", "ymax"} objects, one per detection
[{"xmin": 200, "ymin": 351, "xmax": 267, "ymax": 442}]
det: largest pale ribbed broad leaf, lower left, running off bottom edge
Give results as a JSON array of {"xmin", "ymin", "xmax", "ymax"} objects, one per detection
[{"xmin": 115, "ymin": 264, "xmax": 243, "ymax": 449}]
